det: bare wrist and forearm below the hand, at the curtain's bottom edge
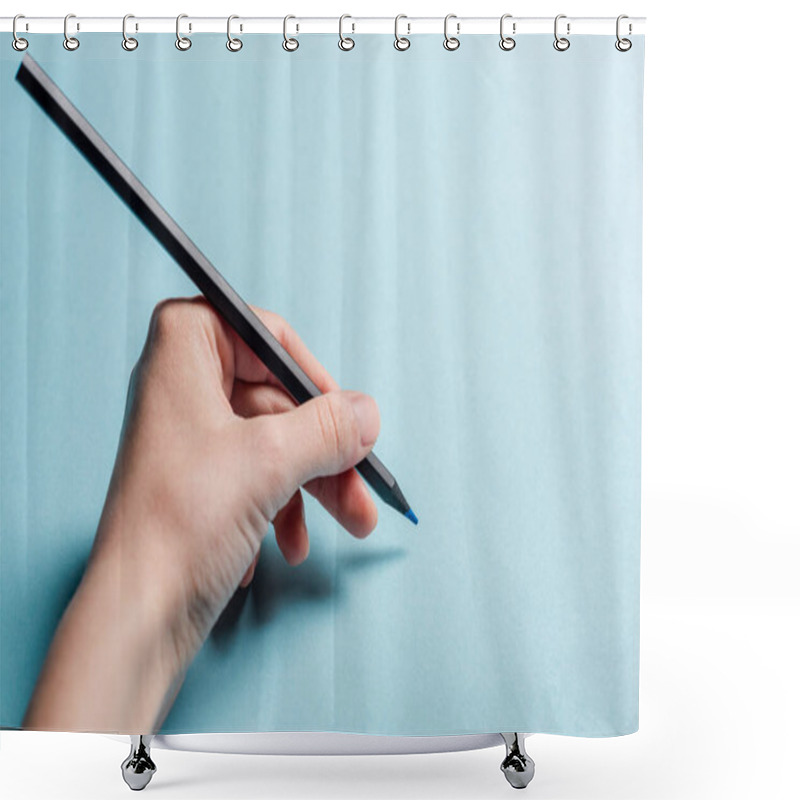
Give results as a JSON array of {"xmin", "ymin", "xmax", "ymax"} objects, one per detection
[{"xmin": 24, "ymin": 512, "xmax": 190, "ymax": 734}]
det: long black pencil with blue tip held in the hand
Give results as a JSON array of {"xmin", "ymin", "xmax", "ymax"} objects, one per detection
[{"xmin": 16, "ymin": 53, "xmax": 417, "ymax": 525}]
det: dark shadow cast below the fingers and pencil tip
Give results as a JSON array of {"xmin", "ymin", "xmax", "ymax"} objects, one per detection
[{"xmin": 211, "ymin": 544, "xmax": 406, "ymax": 647}]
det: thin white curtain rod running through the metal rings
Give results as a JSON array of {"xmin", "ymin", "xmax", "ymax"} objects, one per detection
[{"xmin": 0, "ymin": 16, "xmax": 646, "ymax": 36}]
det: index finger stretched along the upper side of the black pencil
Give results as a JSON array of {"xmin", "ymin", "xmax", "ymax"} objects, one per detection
[{"xmin": 229, "ymin": 306, "xmax": 339, "ymax": 392}]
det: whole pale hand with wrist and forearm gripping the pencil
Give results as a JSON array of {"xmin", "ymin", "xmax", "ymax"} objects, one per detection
[{"xmin": 23, "ymin": 297, "xmax": 380, "ymax": 734}]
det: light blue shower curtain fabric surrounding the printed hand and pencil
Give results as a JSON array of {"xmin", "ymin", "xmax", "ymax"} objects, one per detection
[{"xmin": 0, "ymin": 34, "xmax": 644, "ymax": 736}]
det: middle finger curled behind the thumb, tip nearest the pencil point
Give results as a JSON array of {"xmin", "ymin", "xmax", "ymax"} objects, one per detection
[{"xmin": 231, "ymin": 381, "xmax": 378, "ymax": 538}]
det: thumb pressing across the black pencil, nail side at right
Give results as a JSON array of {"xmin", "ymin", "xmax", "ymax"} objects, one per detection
[{"xmin": 266, "ymin": 390, "xmax": 381, "ymax": 487}]
